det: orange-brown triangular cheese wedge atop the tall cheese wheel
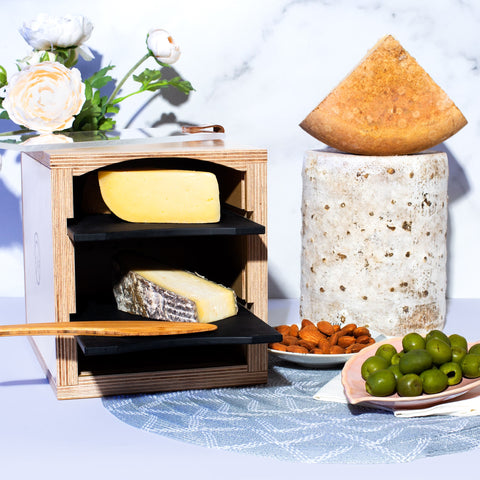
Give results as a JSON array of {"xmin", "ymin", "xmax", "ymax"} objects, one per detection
[{"xmin": 300, "ymin": 35, "xmax": 467, "ymax": 155}]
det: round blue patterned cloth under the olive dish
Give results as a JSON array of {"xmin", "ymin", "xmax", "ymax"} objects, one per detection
[{"xmin": 103, "ymin": 359, "xmax": 480, "ymax": 464}]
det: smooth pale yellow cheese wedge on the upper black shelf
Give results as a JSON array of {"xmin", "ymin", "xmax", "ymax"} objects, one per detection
[{"xmin": 98, "ymin": 170, "xmax": 220, "ymax": 223}]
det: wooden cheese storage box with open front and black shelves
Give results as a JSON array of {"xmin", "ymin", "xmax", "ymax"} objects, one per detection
[{"xmin": 22, "ymin": 137, "xmax": 277, "ymax": 399}]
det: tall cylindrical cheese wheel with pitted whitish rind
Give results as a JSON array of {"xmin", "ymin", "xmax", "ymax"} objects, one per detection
[{"xmin": 300, "ymin": 151, "xmax": 448, "ymax": 335}]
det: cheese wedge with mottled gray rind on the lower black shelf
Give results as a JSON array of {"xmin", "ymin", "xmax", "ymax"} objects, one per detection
[{"xmin": 113, "ymin": 268, "xmax": 238, "ymax": 323}]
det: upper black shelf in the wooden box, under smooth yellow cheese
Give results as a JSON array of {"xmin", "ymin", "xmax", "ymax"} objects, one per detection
[{"xmin": 68, "ymin": 208, "xmax": 265, "ymax": 243}]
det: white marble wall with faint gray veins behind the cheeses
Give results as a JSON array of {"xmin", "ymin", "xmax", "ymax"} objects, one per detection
[{"xmin": 0, "ymin": 0, "xmax": 480, "ymax": 298}]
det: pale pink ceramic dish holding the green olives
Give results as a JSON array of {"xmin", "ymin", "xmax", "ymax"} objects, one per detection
[{"xmin": 342, "ymin": 337, "xmax": 480, "ymax": 410}]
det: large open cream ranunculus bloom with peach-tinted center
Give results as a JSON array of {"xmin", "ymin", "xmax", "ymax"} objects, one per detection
[{"xmin": 3, "ymin": 62, "xmax": 85, "ymax": 133}]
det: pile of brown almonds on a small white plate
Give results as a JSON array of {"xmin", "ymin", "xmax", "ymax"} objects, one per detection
[{"xmin": 269, "ymin": 319, "xmax": 375, "ymax": 354}]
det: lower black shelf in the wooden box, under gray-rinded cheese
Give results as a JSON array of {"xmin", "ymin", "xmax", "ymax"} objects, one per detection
[{"xmin": 70, "ymin": 302, "xmax": 282, "ymax": 357}]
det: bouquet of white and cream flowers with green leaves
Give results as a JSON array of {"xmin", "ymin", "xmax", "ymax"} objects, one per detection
[{"xmin": 0, "ymin": 14, "xmax": 193, "ymax": 133}]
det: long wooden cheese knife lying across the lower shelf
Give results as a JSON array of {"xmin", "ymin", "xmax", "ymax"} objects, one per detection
[{"xmin": 0, "ymin": 320, "xmax": 217, "ymax": 337}]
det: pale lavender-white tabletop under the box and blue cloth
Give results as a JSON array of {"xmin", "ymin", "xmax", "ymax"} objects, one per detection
[{"xmin": 0, "ymin": 298, "xmax": 480, "ymax": 480}]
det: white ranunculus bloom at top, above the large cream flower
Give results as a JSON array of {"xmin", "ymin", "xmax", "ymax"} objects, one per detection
[{"xmin": 20, "ymin": 13, "xmax": 93, "ymax": 50}]
